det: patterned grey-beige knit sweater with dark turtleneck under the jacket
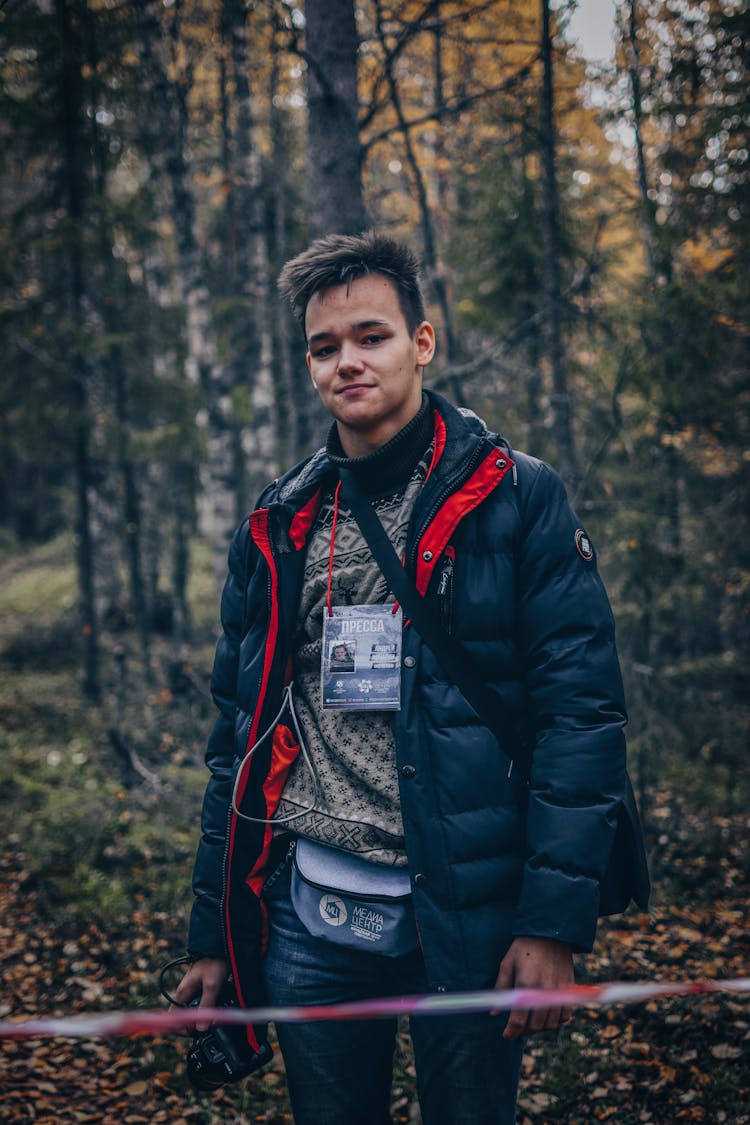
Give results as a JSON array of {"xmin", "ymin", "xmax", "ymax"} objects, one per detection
[{"xmin": 277, "ymin": 399, "xmax": 432, "ymax": 866}]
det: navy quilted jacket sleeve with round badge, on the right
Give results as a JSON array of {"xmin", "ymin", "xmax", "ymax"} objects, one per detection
[{"xmin": 514, "ymin": 462, "xmax": 626, "ymax": 951}]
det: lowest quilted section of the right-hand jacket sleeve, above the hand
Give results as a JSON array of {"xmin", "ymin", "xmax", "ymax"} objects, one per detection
[{"xmin": 513, "ymin": 866, "xmax": 599, "ymax": 953}]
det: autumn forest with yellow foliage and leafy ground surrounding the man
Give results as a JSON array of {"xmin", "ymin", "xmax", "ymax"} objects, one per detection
[{"xmin": 0, "ymin": 0, "xmax": 750, "ymax": 1125}]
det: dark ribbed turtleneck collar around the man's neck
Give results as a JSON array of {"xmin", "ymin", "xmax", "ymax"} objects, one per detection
[{"xmin": 326, "ymin": 394, "xmax": 433, "ymax": 496}]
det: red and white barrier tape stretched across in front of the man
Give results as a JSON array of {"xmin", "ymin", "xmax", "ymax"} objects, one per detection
[{"xmin": 0, "ymin": 977, "xmax": 750, "ymax": 1040}]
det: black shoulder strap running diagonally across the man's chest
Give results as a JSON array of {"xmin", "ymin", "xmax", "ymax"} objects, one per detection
[{"xmin": 340, "ymin": 469, "xmax": 526, "ymax": 776}]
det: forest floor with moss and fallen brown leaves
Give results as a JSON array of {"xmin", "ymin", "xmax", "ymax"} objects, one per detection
[{"xmin": 0, "ymin": 539, "xmax": 750, "ymax": 1125}]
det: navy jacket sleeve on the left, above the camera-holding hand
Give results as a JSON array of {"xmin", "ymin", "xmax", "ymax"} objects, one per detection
[{"xmin": 188, "ymin": 520, "xmax": 255, "ymax": 957}]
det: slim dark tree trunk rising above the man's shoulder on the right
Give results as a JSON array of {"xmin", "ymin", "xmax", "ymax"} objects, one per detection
[{"xmin": 541, "ymin": 0, "xmax": 578, "ymax": 488}]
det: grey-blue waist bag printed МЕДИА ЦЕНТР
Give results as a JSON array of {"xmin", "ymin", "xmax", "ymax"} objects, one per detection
[{"xmin": 291, "ymin": 837, "xmax": 419, "ymax": 957}]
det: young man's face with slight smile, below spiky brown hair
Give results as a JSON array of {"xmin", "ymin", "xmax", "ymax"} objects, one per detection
[{"xmin": 305, "ymin": 273, "xmax": 435, "ymax": 457}]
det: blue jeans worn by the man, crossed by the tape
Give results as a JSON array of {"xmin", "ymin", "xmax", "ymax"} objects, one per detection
[{"xmin": 264, "ymin": 855, "xmax": 523, "ymax": 1125}]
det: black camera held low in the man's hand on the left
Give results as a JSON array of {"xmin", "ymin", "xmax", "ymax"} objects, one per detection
[{"xmin": 188, "ymin": 990, "xmax": 273, "ymax": 1090}]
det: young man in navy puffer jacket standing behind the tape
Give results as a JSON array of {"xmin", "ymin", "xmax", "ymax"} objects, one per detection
[{"xmin": 178, "ymin": 234, "xmax": 648, "ymax": 1125}]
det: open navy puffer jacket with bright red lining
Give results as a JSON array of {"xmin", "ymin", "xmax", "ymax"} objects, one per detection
[{"xmin": 189, "ymin": 393, "xmax": 648, "ymax": 1035}]
